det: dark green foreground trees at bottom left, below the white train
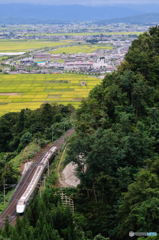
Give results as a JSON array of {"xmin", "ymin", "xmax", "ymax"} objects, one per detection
[{"xmin": 0, "ymin": 178, "xmax": 109, "ymax": 240}]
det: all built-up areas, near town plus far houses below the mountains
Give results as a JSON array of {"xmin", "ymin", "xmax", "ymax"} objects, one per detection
[{"xmin": 0, "ymin": 23, "xmax": 148, "ymax": 75}]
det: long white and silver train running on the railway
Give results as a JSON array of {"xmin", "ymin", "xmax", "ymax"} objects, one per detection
[{"xmin": 16, "ymin": 147, "xmax": 57, "ymax": 214}]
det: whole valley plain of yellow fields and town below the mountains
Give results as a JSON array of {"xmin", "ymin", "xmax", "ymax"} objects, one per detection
[{"xmin": 0, "ymin": 23, "xmax": 144, "ymax": 116}]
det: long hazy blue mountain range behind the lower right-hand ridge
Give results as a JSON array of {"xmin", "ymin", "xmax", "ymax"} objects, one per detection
[{"xmin": 0, "ymin": 4, "xmax": 142, "ymax": 24}]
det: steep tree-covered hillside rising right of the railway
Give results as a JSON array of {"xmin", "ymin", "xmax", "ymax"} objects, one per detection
[{"xmin": 68, "ymin": 27, "xmax": 159, "ymax": 240}]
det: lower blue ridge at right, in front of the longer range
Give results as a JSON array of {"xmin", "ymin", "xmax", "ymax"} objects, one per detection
[{"xmin": 97, "ymin": 13, "xmax": 159, "ymax": 25}]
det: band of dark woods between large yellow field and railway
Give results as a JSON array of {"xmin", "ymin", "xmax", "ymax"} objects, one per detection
[{"xmin": 0, "ymin": 103, "xmax": 73, "ymax": 152}]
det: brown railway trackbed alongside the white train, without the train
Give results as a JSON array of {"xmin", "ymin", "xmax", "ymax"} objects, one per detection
[{"xmin": 0, "ymin": 129, "xmax": 74, "ymax": 227}]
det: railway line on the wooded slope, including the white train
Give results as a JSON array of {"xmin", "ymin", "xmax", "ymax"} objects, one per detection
[{"xmin": 0, "ymin": 129, "xmax": 74, "ymax": 227}]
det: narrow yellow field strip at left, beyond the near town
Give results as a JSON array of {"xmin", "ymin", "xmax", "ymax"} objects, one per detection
[{"xmin": 0, "ymin": 40, "xmax": 70, "ymax": 52}]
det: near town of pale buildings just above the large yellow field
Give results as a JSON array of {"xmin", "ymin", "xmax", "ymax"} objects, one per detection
[{"xmin": 3, "ymin": 39, "xmax": 131, "ymax": 74}]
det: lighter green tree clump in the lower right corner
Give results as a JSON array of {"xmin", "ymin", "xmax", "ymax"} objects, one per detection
[{"xmin": 118, "ymin": 163, "xmax": 159, "ymax": 239}]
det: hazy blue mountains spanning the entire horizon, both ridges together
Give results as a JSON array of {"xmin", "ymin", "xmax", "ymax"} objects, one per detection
[{"xmin": 0, "ymin": 3, "xmax": 159, "ymax": 24}]
